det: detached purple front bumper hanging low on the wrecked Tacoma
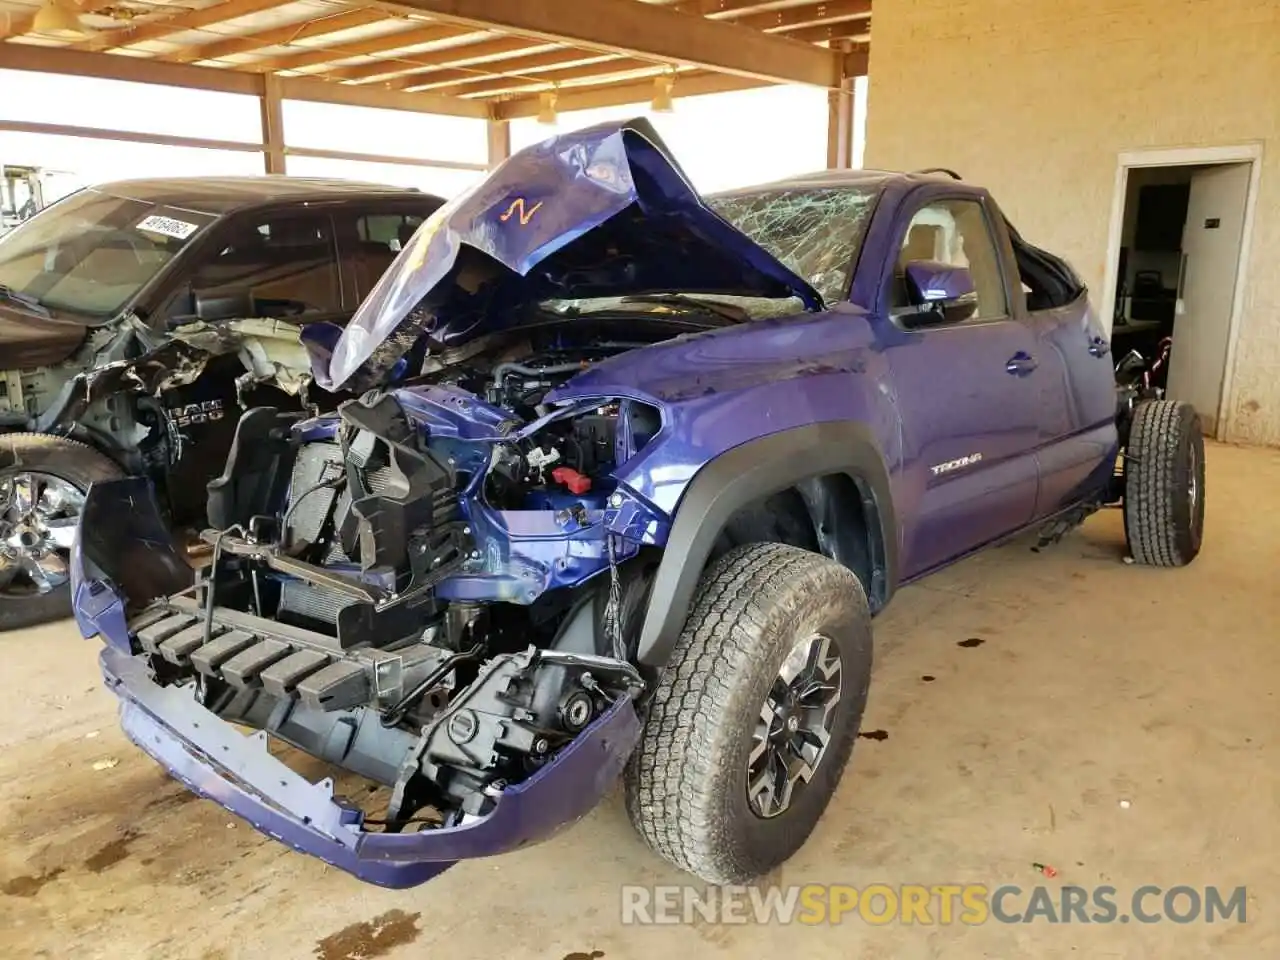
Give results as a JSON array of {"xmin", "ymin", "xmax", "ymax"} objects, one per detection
[{"xmin": 70, "ymin": 479, "xmax": 640, "ymax": 887}]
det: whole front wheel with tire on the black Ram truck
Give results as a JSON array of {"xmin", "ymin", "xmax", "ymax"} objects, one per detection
[{"xmin": 0, "ymin": 434, "xmax": 123, "ymax": 631}]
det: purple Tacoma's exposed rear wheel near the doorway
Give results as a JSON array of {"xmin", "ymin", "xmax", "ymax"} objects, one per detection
[{"xmin": 1124, "ymin": 401, "xmax": 1204, "ymax": 567}]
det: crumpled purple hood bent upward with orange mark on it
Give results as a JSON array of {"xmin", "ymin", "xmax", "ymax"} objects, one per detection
[{"xmin": 312, "ymin": 119, "xmax": 822, "ymax": 390}]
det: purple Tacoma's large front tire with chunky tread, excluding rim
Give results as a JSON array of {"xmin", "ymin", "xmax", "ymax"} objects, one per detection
[{"xmin": 626, "ymin": 543, "xmax": 872, "ymax": 883}]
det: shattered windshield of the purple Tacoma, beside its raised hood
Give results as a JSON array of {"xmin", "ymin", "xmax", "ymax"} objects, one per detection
[{"xmin": 707, "ymin": 186, "xmax": 878, "ymax": 303}]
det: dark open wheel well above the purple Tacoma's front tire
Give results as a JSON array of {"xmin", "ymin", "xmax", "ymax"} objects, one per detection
[{"xmin": 708, "ymin": 474, "xmax": 888, "ymax": 612}]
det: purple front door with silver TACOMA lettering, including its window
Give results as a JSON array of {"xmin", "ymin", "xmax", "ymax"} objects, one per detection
[{"xmin": 877, "ymin": 187, "xmax": 1041, "ymax": 579}]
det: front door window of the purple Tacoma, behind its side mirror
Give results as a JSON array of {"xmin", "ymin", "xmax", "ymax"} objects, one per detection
[{"xmin": 891, "ymin": 200, "xmax": 1009, "ymax": 320}]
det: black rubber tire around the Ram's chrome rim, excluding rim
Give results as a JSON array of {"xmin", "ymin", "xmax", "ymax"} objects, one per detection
[{"xmin": 0, "ymin": 433, "xmax": 124, "ymax": 632}]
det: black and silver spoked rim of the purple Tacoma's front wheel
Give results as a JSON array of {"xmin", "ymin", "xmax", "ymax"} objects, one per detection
[{"xmin": 746, "ymin": 634, "xmax": 841, "ymax": 818}]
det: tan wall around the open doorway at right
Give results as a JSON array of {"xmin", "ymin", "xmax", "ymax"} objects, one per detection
[{"xmin": 865, "ymin": 0, "xmax": 1280, "ymax": 445}]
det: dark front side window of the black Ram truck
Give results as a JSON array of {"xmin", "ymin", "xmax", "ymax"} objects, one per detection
[{"xmin": 191, "ymin": 214, "xmax": 342, "ymax": 317}]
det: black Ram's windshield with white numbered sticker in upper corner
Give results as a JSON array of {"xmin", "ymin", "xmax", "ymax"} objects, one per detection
[{"xmin": 0, "ymin": 189, "xmax": 212, "ymax": 319}]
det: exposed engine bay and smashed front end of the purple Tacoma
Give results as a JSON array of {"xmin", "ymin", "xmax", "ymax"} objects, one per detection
[{"xmin": 117, "ymin": 316, "xmax": 691, "ymax": 831}]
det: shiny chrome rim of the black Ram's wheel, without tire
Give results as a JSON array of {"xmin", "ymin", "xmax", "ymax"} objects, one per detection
[{"xmin": 0, "ymin": 471, "xmax": 84, "ymax": 598}]
